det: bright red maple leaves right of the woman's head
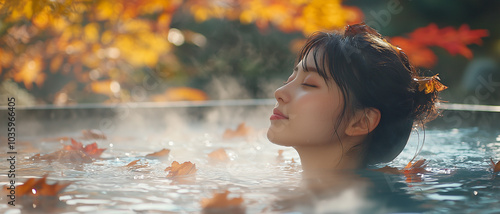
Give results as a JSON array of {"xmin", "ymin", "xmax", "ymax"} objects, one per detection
[{"xmin": 391, "ymin": 23, "xmax": 489, "ymax": 68}]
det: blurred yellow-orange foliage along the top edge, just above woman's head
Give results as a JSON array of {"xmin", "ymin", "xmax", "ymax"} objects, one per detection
[{"xmin": 187, "ymin": 0, "xmax": 364, "ymax": 35}]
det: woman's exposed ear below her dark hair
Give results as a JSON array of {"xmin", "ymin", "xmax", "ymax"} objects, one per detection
[{"xmin": 345, "ymin": 108, "xmax": 381, "ymax": 136}]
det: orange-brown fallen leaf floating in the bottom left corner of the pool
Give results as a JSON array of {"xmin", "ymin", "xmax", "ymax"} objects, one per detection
[{"xmin": 4, "ymin": 175, "xmax": 71, "ymax": 197}]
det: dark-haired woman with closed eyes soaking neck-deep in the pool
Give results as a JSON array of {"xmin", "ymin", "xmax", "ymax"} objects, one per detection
[{"xmin": 267, "ymin": 24, "xmax": 446, "ymax": 171}]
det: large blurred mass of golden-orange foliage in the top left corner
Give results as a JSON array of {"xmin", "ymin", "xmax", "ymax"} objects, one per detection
[{"xmin": 0, "ymin": 0, "xmax": 182, "ymax": 100}]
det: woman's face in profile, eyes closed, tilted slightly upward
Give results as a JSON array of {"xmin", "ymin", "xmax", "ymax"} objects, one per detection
[{"xmin": 267, "ymin": 51, "xmax": 344, "ymax": 146}]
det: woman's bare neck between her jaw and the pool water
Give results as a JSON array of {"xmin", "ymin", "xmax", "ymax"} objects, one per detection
[{"xmin": 294, "ymin": 140, "xmax": 362, "ymax": 172}]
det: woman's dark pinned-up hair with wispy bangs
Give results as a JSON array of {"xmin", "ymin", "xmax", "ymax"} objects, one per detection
[{"xmin": 297, "ymin": 24, "xmax": 438, "ymax": 165}]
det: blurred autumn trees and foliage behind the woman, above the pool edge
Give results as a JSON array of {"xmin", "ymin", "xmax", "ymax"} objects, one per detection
[{"xmin": 0, "ymin": 0, "xmax": 500, "ymax": 106}]
